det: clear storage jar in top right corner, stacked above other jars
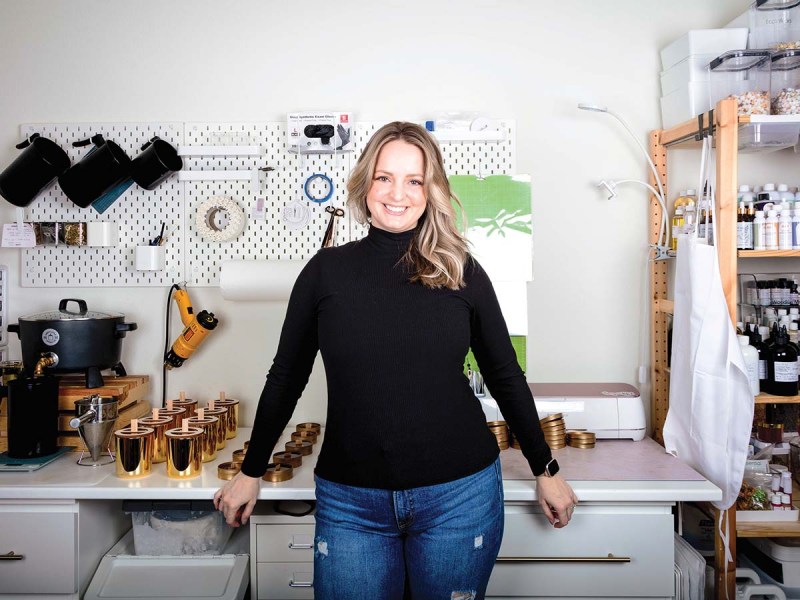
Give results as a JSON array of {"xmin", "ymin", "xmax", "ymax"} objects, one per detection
[{"xmin": 750, "ymin": 0, "xmax": 800, "ymax": 50}]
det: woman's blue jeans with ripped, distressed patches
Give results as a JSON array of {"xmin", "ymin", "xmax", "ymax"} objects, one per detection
[{"xmin": 314, "ymin": 458, "xmax": 503, "ymax": 600}]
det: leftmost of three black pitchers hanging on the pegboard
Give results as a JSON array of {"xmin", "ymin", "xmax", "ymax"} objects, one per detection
[{"xmin": 0, "ymin": 133, "xmax": 70, "ymax": 207}]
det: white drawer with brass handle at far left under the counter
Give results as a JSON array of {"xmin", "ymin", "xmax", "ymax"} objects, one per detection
[{"xmin": 0, "ymin": 506, "xmax": 78, "ymax": 594}]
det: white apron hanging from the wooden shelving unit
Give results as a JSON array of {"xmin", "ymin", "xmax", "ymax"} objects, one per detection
[{"xmin": 664, "ymin": 139, "xmax": 754, "ymax": 509}]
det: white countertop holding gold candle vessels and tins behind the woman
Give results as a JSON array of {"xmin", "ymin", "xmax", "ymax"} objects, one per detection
[{"xmin": 0, "ymin": 427, "xmax": 722, "ymax": 502}]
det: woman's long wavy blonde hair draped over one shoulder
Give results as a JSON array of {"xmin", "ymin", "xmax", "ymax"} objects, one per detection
[{"xmin": 347, "ymin": 121, "xmax": 470, "ymax": 290}]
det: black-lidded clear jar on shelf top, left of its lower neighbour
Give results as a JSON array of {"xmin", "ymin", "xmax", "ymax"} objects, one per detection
[{"xmin": 709, "ymin": 50, "xmax": 771, "ymax": 115}]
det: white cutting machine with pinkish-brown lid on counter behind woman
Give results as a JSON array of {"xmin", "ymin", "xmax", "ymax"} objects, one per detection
[{"xmin": 480, "ymin": 383, "xmax": 646, "ymax": 442}]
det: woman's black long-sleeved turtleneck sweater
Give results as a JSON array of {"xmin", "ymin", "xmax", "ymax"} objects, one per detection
[{"xmin": 242, "ymin": 227, "xmax": 551, "ymax": 490}]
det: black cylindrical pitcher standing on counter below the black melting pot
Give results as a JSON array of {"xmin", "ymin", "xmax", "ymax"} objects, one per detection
[{"xmin": 8, "ymin": 375, "xmax": 58, "ymax": 458}]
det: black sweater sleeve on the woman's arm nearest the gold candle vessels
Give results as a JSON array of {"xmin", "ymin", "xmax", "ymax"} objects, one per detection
[{"xmin": 242, "ymin": 254, "xmax": 321, "ymax": 477}]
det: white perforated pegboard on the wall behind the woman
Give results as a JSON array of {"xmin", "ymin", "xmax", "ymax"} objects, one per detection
[{"xmin": 15, "ymin": 120, "xmax": 515, "ymax": 287}]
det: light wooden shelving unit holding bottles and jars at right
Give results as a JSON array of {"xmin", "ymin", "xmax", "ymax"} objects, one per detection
[{"xmin": 650, "ymin": 99, "xmax": 800, "ymax": 600}]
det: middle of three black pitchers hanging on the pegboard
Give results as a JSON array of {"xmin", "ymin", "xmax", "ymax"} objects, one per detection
[{"xmin": 58, "ymin": 134, "xmax": 131, "ymax": 208}]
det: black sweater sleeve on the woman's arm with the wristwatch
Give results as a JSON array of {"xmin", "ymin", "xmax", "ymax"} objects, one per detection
[{"xmin": 468, "ymin": 261, "xmax": 552, "ymax": 474}]
